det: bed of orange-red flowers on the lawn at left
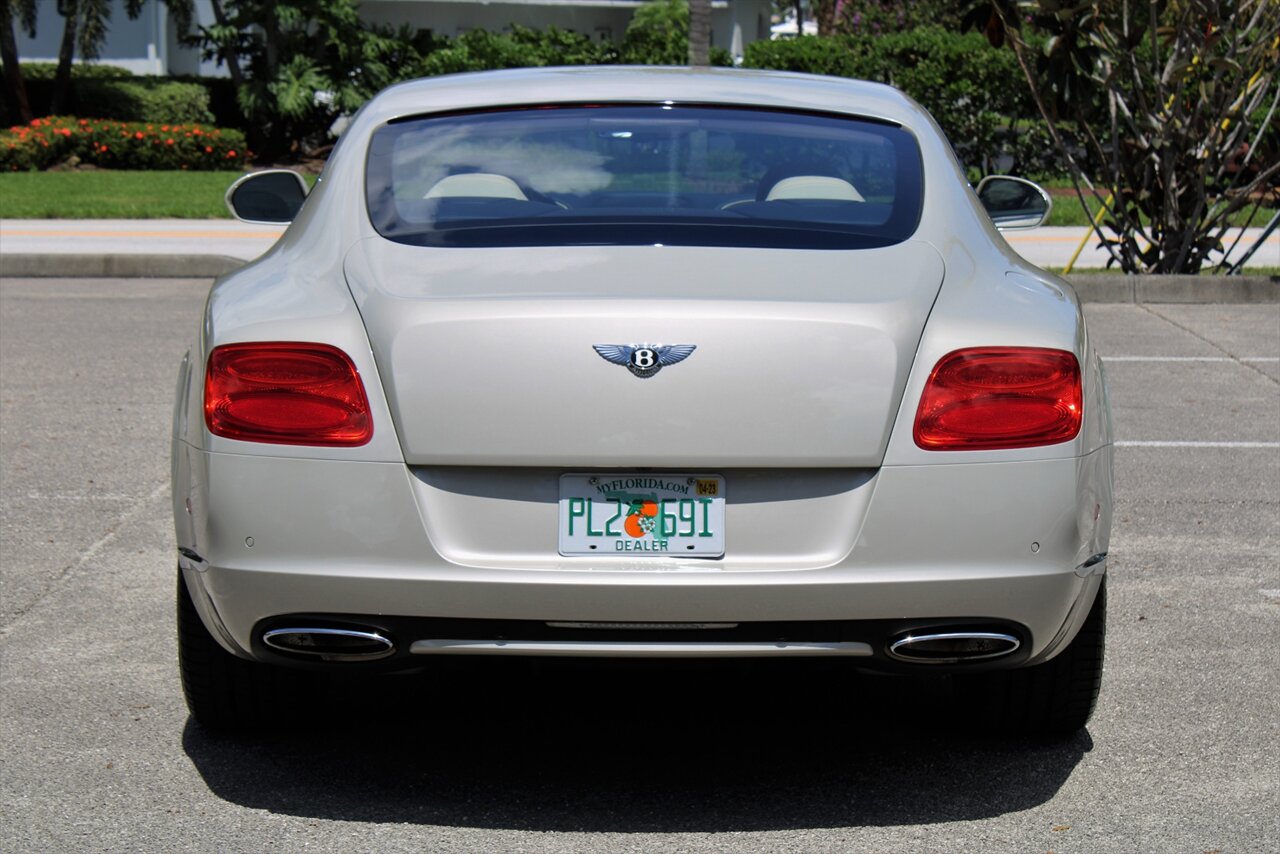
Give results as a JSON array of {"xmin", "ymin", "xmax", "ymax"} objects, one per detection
[{"xmin": 0, "ymin": 117, "xmax": 250, "ymax": 172}]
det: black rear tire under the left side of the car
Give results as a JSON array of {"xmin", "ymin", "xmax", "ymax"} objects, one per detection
[{"xmin": 178, "ymin": 571, "xmax": 324, "ymax": 730}]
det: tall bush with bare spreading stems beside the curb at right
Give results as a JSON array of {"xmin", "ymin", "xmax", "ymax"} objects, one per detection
[{"xmin": 964, "ymin": 0, "xmax": 1280, "ymax": 274}]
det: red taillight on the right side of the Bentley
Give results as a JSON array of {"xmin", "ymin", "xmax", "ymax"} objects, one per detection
[{"xmin": 915, "ymin": 347, "xmax": 1082, "ymax": 451}]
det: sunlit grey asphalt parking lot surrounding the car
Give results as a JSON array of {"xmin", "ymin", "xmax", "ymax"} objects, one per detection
[{"xmin": 0, "ymin": 279, "xmax": 1280, "ymax": 854}]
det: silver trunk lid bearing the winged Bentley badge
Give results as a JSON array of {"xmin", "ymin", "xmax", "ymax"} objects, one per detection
[{"xmin": 346, "ymin": 238, "xmax": 943, "ymax": 471}]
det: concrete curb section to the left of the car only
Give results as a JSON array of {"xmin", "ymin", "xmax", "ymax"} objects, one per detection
[{"xmin": 0, "ymin": 254, "xmax": 247, "ymax": 279}]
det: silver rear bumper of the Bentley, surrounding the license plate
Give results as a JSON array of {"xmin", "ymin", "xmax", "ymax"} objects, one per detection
[{"xmin": 174, "ymin": 446, "xmax": 1111, "ymax": 661}]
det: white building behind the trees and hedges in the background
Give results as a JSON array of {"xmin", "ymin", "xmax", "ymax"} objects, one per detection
[{"xmin": 17, "ymin": 0, "xmax": 771, "ymax": 76}]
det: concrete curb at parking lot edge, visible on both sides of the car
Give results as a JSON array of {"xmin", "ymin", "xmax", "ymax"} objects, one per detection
[{"xmin": 0, "ymin": 254, "xmax": 1280, "ymax": 303}]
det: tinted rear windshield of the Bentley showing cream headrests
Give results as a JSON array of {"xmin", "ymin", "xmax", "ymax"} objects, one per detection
[{"xmin": 367, "ymin": 105, "xmax": 922, "ymax": 248}]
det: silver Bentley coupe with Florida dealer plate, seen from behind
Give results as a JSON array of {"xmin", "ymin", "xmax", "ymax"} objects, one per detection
[{"xmin": 173, "ymin": 68, "xmax": 1112, "ymax": 734}]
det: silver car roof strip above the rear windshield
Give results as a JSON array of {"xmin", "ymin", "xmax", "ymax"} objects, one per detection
[{"xmin": 364, "ymin": 65, "xmax": 928, "ymax": 127}]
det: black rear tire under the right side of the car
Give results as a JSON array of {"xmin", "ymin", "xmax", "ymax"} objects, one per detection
[{"xmin": 955, "ymin": 577, "xmax": 1107, "ymax": 737}]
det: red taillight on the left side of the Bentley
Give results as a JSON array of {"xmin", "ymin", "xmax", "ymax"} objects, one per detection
[{"xmin": 205, "ymin": 342, "xmax": 374, "ymax": 447}]
